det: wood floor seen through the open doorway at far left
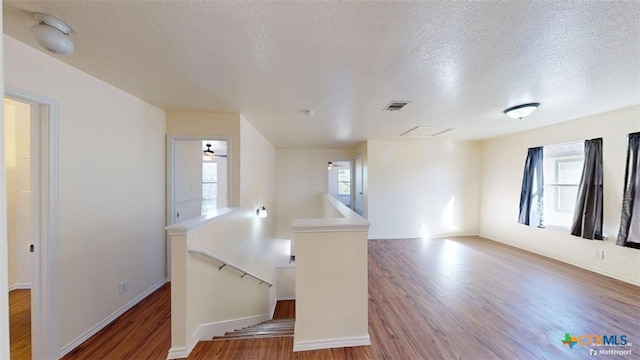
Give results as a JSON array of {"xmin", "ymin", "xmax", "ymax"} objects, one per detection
[{"xmin": 9, "ymin": 290, "xmax": 31, "ymax": 360}]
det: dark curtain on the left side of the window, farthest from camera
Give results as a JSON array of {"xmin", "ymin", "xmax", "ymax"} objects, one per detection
[{"xmin": 518, "ymin": 147, "xmax": 544, "ymax": 227}]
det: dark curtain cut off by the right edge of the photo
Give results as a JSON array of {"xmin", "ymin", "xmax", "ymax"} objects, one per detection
[{"xmin": 616, "ymin": 132, "xmax": 640, "ymax": 249}]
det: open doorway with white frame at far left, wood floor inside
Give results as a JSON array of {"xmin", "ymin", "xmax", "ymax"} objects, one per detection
[{"xmin": 2, "ymin": 87, "xmax": 59, "ymax": 359}]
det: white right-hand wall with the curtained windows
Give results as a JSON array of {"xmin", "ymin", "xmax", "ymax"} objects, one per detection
[{"xmin": 480, "ymin": 106, "xmax": 640, "ymax": 285}]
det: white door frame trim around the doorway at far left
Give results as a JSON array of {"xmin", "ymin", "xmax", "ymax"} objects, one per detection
[{"xmin": 4, "ymin": 84, "xmax": 60, "ymax": 359}]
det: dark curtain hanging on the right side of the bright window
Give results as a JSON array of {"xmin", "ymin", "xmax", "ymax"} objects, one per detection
[{"xmin": 571, "ymin": 138, "xmax": 603, "ymax": 240}]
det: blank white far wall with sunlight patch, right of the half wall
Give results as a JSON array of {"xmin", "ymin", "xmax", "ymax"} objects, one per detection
[{"xmin": 367, "ymin": 140, "xmax": 480, "ymax": 239}]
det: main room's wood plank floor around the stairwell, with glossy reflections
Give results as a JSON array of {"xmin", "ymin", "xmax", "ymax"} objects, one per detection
[{"xmin": 57, "ymin": 237, "xmax": 640, "ymax": 360}]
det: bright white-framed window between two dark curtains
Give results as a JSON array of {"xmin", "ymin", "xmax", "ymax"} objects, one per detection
[{"xmin": 543, "ymin": 141, "xmax": 584, "ymax": 228}]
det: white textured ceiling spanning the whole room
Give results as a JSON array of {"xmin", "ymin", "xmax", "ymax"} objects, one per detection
[{"xmin": 4, "ymin": 1, "xmax": 640, "ymax": 148}]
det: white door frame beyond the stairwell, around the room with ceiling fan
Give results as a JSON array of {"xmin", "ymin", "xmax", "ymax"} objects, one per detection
[{"xmin": 166, "ymin": 134, "xmax": 232, "ymax": 281}]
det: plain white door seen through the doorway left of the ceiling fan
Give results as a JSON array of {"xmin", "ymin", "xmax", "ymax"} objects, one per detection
[{"xmin": 173, "ymin": 140, "xmax": 202, "ymax": 223}]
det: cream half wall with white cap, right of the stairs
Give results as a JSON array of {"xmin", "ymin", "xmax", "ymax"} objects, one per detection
[{"xmin": 293, "ymin": 195, "xmax": 371, "ymax": 351}]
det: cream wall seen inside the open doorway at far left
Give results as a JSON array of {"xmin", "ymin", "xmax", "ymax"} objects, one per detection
[{"xmin": 4, "ymin": 99, "xmax": 34, "ymax": 289}]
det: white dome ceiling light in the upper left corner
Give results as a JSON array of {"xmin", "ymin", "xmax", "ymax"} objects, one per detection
[{"xmin": 31, "ymin": 13, "xmax": 74, "ymax": 55}]
